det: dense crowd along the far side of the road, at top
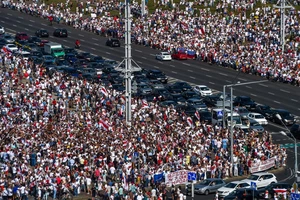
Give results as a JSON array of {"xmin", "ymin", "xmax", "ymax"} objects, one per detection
[{"xmin": 1, "ymin": 0, "xmax": 300, "ymax": 86}]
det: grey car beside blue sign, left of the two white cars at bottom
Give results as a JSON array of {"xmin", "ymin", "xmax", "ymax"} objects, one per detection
[{"xmin": 186, "ymin": 178, "xmax": 226, "ymax": 195}]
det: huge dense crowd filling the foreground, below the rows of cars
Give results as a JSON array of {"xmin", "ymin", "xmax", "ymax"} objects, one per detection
[{"xmin": 0, "ymin": 45, "xmax": 287, "ymax": 199}]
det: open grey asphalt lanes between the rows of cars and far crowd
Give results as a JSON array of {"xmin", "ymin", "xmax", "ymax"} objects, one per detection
[{"xmin": 0, "ymin": 8, "xmax": 300, "ymax": 116}]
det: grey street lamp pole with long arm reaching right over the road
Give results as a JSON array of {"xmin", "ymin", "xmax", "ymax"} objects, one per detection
[{"xmin": 222, "ymin": 80, "xmax": 268, "ymax": 174}]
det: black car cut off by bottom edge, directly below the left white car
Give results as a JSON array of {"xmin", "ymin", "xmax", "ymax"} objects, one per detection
[{"xmin": 224, "ymin": 188, "xmax": 260, "ymax": 200}]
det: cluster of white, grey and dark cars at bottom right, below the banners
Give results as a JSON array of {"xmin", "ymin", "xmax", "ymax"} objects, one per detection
[{"xmin": 185, "ymin": 172, "xmax": 292, "ymax": 200}]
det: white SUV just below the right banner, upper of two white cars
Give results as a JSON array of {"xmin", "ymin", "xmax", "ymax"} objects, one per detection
[{"xmin": 242, "ymin": 172, "xmax": 277, "ymax": 188}]
